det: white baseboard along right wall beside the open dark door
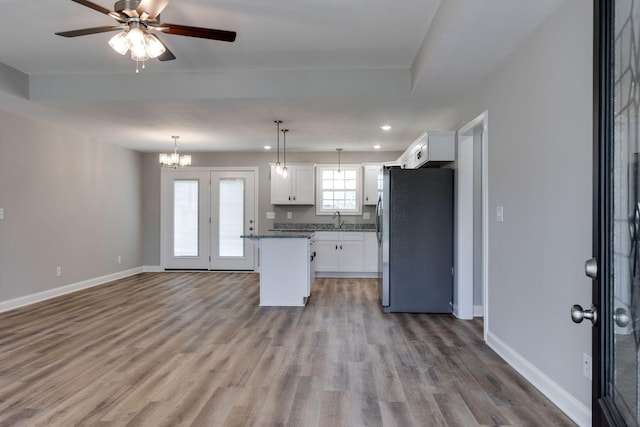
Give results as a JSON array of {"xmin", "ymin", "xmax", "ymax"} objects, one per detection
[{"xmin": 487, "ymin": 331, "xmax": 591, "ymax": 427}]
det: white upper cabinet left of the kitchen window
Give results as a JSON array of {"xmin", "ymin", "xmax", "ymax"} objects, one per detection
[{"xmin": 271, "ymin": 164, "xmax": 315, "ymax": 205}]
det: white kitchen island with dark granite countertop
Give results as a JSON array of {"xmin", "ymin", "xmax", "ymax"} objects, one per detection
[{"xmin": 241, "ymin": 232, "xmax": 315, "ymax": 307}]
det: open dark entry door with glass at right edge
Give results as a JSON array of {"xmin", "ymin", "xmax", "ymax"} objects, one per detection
[{"xmin": 586, "ymin": 0, "xmax": 640, "ymax": 426}]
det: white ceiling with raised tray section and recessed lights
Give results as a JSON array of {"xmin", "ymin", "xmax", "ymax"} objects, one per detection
[{"xmin": 0, "ymin": 0, "xmax": 563, "ymax": 152}]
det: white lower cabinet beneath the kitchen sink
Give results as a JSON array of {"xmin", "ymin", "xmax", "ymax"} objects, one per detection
[{"xmin": 315, "ymin": 231, "xmax": 378, "ymax": 275}]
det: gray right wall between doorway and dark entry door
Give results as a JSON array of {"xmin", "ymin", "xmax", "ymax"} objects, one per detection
[{"xmin": 439, "ymin": 0, "xmax": 593, "ymax": 416}]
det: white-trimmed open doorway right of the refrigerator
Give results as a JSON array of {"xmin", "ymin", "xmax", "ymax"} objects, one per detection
[{"xmin": 454, "ymin": 111, "xmax": 488, "ymax": 335}]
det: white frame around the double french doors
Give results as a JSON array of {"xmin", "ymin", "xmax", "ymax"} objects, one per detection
[{"xmin": 160, "ymin": 166, "xmax": 260, "ymax": 272}]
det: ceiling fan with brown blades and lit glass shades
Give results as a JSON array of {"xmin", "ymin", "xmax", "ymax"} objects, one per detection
[{"xmin": 55, "ymin": 0, "xmax": 236, "ymax": 63}]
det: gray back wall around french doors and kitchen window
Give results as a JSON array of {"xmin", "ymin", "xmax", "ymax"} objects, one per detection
[{"xmin": 142, "ymin": 151, "xmax": 401, "ymax": 267}]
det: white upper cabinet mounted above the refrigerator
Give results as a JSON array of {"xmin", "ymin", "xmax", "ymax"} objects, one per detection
[{"xmin": 398, "ymin": 131, "xmax": 456, "ymax": 169}]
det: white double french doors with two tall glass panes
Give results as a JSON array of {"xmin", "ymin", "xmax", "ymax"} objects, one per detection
[{"xmin": 162, "ymin": 168, "xmax": 256, "ymax": 270}]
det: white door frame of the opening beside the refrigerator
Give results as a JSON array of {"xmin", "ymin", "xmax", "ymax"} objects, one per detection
[{"xmin": 454, "ymin": 111, "xmax": 489, "ymax": 341}]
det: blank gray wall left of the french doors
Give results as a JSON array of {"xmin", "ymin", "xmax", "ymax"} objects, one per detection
[{"xmin": 0, "ymin": 110, "xmax": 142, "ymax": 303}]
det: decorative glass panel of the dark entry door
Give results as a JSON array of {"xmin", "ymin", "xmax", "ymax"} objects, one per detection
[{"xmin": 607, "ymin": 0, "xmax": 640, "ymax": 426}]
